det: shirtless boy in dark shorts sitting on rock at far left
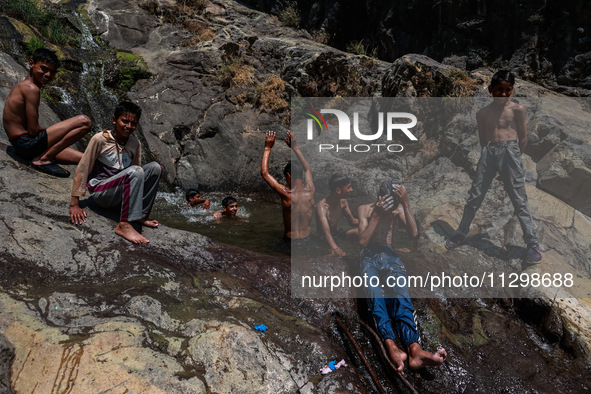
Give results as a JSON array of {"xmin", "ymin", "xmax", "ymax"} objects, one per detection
[{"xmin": 2, "ymin": 48, "xmax": 90, "ymax": 178}]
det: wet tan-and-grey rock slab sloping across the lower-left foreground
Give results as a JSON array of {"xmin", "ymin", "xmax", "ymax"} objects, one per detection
[{"xmin": 0, "ymin": 145, "xmax": 364, "ymax": 393}]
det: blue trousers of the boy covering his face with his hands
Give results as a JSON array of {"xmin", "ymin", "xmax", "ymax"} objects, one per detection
[{"xmin": 361, "ymin": 245, "xmax": 419, "ymax": 348}]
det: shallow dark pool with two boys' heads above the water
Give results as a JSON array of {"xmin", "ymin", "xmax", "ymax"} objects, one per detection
[{"xmin": 151, "ymin": 189, "xmax": 290, "ymax": 256}]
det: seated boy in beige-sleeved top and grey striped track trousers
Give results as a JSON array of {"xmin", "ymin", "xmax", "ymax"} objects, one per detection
[{"xmin": 70, "ymin": 101, "xmax": 162, "ymax": 244}]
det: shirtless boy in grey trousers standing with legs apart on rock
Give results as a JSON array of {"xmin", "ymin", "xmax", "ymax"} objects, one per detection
[{"xmin": 445, "ymin": 70, "xmax": 542, "ymax": 264}]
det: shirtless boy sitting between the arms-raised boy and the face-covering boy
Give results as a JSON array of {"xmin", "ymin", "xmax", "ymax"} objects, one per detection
[{"xmin": 316, "ymin": 173, "xmax": 359, "ymax": 256}]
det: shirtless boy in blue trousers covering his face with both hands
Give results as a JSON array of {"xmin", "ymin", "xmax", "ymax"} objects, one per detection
[{"xmin": 358, "ymin": 179, "xmax": 447, "ymax": 373}]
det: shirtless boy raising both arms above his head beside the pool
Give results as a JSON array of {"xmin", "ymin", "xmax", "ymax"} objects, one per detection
[{"xmin": 261, "ymin": 131, "xmax": 315, "ymax": 240}]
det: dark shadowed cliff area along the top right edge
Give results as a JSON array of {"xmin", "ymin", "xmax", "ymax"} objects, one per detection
[{"xmin": 247, "ymin": 0, "xmax": 591, "ymax": 96}]
